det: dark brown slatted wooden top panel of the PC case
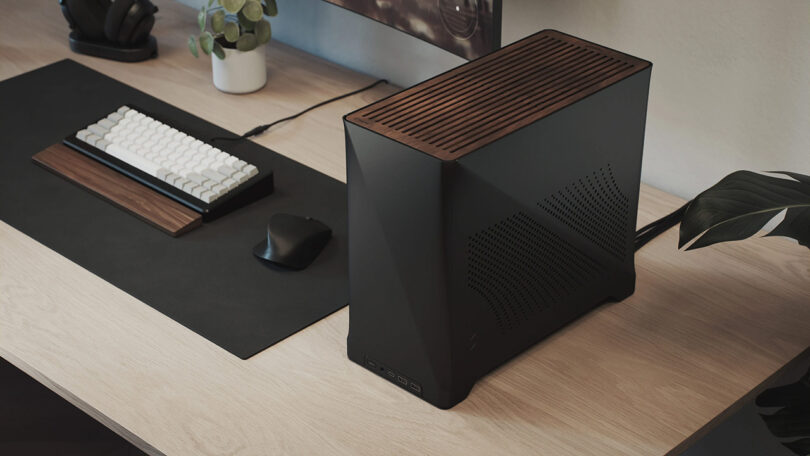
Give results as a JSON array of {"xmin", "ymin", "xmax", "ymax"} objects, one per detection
[{"xmin": 346, "ymin": 30, "xmax": 650, "ymax": 160}]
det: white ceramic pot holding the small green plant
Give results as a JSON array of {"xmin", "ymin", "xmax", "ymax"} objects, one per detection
[{"xmin": 211, "ymin": 45, "xmax": 267, "ymax": 93}]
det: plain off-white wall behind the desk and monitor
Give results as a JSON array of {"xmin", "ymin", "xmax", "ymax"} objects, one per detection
[{"xmin": 181, "ymin": 0, "xmax": 810, "ymax": 197}]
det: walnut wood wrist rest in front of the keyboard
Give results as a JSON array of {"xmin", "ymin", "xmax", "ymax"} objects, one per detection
[{"xmin": 31, "ymin": 144, "xmax": 202, "ymax": 237}]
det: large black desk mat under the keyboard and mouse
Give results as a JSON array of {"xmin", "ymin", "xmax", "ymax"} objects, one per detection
[{"xmin": 0, "ymin": 60, "xmax": 348, "ymax": 359}]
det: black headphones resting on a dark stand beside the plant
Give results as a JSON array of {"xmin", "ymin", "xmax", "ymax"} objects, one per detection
[{"xmin": 59, "ymin": 0, "xmax": 157, "ymax": 46}]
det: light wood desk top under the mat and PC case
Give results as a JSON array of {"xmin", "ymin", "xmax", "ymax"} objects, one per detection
[{"xmin": 0, "ymin": 0, "xmax": 810, "ymax": 456}]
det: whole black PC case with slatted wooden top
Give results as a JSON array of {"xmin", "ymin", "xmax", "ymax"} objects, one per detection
[{"xmin": 344, "ymin": 30, "xmax": 652, "ymax": 408}]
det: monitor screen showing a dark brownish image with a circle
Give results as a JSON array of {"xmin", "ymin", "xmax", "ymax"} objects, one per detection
[{"xmin": 326, "ymin": 0, "xmax": 501, "ymax": 59}]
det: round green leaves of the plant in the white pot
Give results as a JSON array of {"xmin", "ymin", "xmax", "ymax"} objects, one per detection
[{"xmin": 188, "ymin": 0, "xmax": 278, "ymax": 59}]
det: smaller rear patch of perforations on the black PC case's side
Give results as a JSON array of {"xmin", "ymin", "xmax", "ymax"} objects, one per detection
[{"xmin": 537, "ymin": 164, "xmax": 630, "ymax": 259}]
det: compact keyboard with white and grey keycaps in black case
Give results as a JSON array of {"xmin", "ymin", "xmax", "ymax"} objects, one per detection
[{"xmin": 64, "ymin": 106, "xmax": 273, "ymax": 220}]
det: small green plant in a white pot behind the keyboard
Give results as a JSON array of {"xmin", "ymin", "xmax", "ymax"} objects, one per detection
[{"xmin": 188, "ymin": 0, "xmax": 278, "ymax": 93}]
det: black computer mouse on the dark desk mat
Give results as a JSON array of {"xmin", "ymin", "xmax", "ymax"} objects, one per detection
[{"xmin": 253, "ymin": 214, "xmax": 332, "ymax": 270}]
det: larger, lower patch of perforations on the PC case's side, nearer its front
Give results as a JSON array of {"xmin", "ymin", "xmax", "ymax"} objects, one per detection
[{"xmin": 467, "ymin": 212, "xmax": 599, "ymax": 333}]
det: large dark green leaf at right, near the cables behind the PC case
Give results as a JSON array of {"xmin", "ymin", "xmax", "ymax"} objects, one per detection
[{"xmin": 678, "ymin": 171, "xmax": 810, "ymax": 249}]
